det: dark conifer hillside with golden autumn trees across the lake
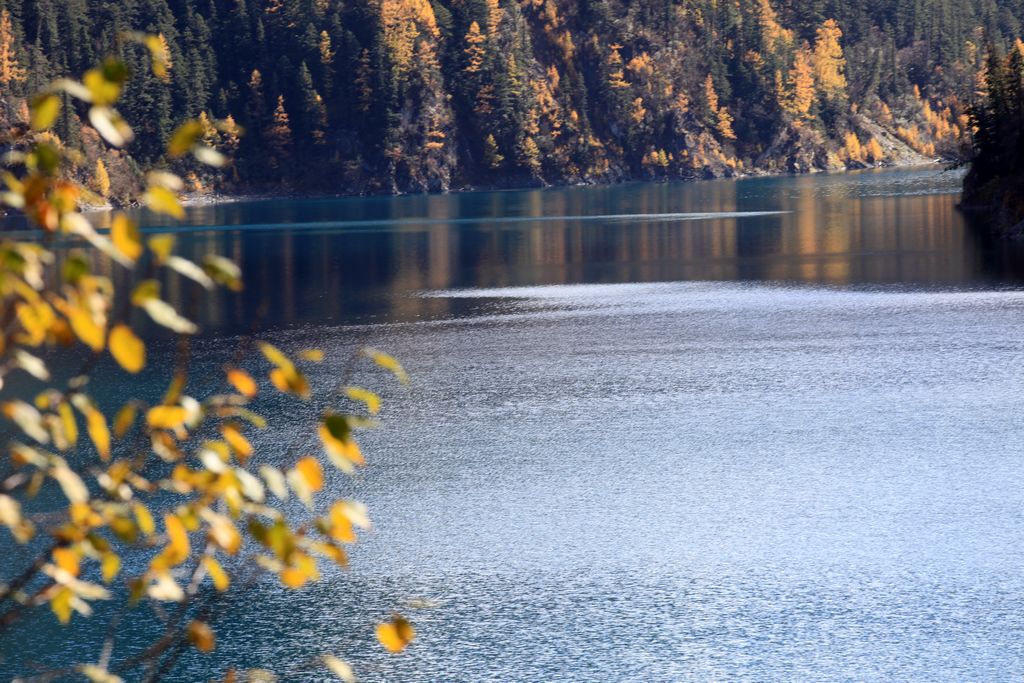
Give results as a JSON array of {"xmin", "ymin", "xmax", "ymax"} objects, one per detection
[{"xmin": 0, "ymin": 0, "xmax": 1024, "ymax": 201}]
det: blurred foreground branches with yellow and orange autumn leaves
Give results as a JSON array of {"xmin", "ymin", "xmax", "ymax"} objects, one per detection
[{"xmin": 0, "ymin": 44, "xmax": 415, "ymax": 683}]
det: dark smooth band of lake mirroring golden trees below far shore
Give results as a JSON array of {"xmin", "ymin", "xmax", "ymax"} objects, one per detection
[{"xmin": 59, "ymin": 167, "xmax": 1024, "ymax": 331}]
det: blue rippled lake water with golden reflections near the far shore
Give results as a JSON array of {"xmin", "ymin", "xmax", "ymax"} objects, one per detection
[{"xmin": 6, "ymin": 168, "xmax": 1024, "ymax": 682}]
